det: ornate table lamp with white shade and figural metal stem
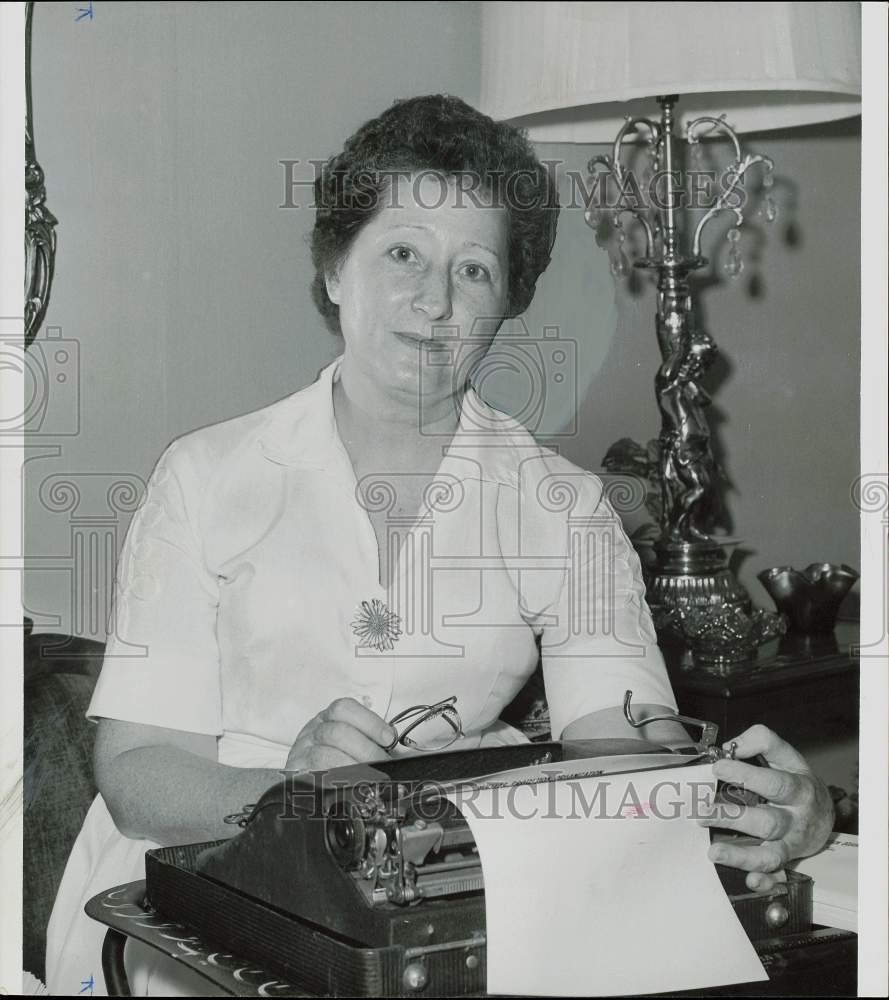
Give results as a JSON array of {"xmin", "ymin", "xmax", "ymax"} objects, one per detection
[{"xmin": 481, "ymin": 2, "xmax": 861, "ymax": 628}]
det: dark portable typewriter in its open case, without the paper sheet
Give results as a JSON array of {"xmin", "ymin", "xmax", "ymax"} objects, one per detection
[{"xmin": 146, "ymin": 708, "xmax": 812, "ymax": 996}]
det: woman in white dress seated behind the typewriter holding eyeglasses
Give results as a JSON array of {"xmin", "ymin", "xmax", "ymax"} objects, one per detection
[{"xmin": 41, "ymin": 96, "xmax": 832, "ymax": 995}]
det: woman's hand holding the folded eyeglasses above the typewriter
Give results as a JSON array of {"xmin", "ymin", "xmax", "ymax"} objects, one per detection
[{"xmin": 284, "ymin": 698, "xmax": 397, "ymax": 771}]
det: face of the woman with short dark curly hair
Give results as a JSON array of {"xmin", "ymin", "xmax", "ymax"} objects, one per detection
[{"xmin": 327, "ymin": 174, "xmax": 509, "ymax": 401}]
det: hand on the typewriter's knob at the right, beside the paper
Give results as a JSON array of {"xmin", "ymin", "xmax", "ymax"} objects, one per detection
[{"xmin": 701, "ymin": 725, "xmax": 834, "ymax": 892}]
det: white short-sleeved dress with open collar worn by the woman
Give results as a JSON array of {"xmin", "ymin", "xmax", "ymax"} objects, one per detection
[{"xmin": 47, "ymin": 359, "xmax": 675, "ymax": 995}]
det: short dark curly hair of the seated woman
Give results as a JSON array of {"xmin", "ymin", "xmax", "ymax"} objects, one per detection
[{"xmin": 311, "ymin": 94, "xmax": 559, "ymax": 333}]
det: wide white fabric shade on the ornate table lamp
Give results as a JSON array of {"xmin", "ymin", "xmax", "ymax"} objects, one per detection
[{"xmin": 481, "ymin": 2, "xmax": 861, "ymax": 142}]
